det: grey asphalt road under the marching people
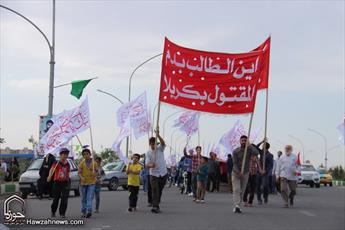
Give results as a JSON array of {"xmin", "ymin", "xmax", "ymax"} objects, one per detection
[{"xmin": 0, "ymin": 186, "xmax": 345, "ymax": 230}]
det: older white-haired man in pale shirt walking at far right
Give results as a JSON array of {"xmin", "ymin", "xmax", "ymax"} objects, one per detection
[{"xmin": 275, "ymin": 145, "xmax": 297, "ymax": 208}]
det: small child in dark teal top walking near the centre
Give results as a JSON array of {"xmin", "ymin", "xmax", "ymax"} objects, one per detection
[{"xmin": 195, "ymin": 157, "xmax": 208, "ymax": 203}]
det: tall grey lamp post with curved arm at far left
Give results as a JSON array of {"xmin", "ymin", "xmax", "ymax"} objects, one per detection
[{"xmin": 0, "ymin": 0, "xmax": 55, "ymax": 116}]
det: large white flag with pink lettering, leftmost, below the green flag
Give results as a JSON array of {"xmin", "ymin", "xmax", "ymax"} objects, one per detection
[{"xmin": 40, "ymin": 98, "xmax": 90, "ymax": 154}]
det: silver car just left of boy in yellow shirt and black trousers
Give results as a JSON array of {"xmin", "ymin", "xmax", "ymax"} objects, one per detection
[{"xmin": 102, "ymin": 161, "xmax": 128, "ymax": 191}]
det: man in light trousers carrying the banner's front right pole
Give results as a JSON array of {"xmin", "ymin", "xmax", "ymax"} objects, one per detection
[{"xmin": 232, "ymin": 135, "xmax": 259, "ymax": 213}]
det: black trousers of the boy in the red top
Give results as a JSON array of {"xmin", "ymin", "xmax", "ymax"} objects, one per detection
[{"xmin": 51, "ymin": 181, "xmax": 70, "ymax": 215}]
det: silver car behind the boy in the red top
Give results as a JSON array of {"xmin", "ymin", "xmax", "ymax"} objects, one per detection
[{"xmin": 19, "ymin": 158, "xmax": 80, "ymax": 199}]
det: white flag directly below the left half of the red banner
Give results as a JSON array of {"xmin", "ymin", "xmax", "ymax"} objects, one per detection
[{"xmin": 173, "ymin": 111, "xmax": 200, "ymax": 136}]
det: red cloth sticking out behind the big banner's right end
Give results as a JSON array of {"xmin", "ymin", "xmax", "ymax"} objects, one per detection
[{"xmin": 253, "ymin": 37, "xmax": 271, "ymax": 90}]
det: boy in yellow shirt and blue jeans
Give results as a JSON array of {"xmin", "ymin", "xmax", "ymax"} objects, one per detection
[{"xmin": 78, "ymin": 149, "xmax": 98, "ymax": 218}]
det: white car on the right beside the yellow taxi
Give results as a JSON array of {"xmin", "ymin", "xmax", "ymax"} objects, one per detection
[{"xmin": 298, "ymin": 164, "xmax": 320, "ymax": 188}]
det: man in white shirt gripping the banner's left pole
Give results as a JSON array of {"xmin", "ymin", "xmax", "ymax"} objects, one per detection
[{"xmin": 146, "ymin": 127, "xmax": 168, "ymax": 213}]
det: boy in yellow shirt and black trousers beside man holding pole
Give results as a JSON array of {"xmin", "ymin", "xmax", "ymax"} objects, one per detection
[{"xmin": 127, "ymin": 153, "xmax": 142, "ymax": 212}]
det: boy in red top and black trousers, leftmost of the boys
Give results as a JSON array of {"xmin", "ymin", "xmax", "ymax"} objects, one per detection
[{"xmin": 47, "ymin": 148, "xmax": 71, "ymax": 218}]
